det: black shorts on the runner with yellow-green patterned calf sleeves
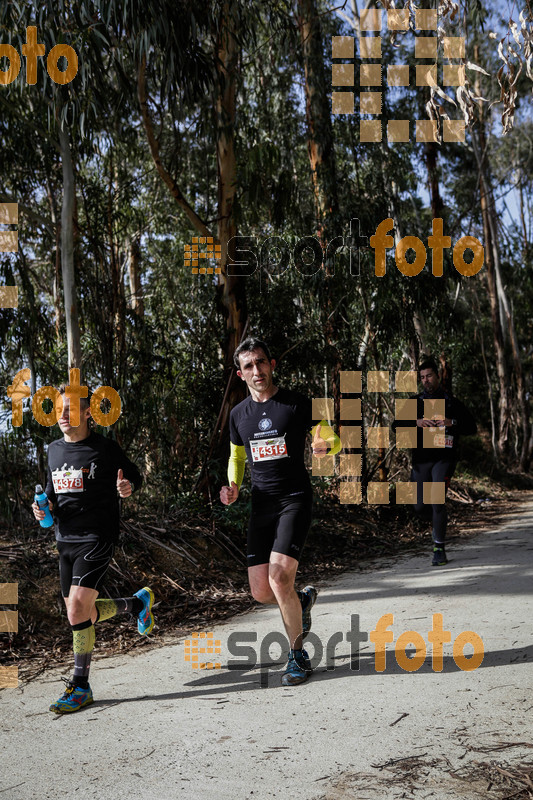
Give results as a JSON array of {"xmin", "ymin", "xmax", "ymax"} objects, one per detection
[{"xmin": 57, "ymin": 539, "xmax": 115, "ymax": 597}]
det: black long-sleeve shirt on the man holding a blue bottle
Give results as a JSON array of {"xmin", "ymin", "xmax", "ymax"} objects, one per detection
[{"xmin": 45, "ymin": 431, "xmax": 142, "ymax": 542}]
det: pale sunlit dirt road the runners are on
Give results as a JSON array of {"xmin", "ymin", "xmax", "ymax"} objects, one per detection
[{"xmin": 0, "ymin": 503, "xmax": 533, "ymax": 800}]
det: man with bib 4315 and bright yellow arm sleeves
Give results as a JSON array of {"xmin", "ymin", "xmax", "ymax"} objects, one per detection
[{"xmin": 220, "ymin": 337, "xmax": 340, "ymax": 686}]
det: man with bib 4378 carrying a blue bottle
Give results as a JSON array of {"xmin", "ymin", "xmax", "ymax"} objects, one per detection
[{"xmin": 32, "ymin": 387, "xmax": 154, "ymax": 714}]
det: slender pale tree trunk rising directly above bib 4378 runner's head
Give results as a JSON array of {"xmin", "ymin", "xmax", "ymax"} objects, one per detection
[{"xmin": 59, "ymin": 127, "xmax": 81, "ymax": 369}]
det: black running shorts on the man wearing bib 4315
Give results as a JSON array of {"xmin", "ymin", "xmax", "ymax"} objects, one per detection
[{"xmin": 247, "ymin": 491, "xmax": 313, "ymax": 567}]
